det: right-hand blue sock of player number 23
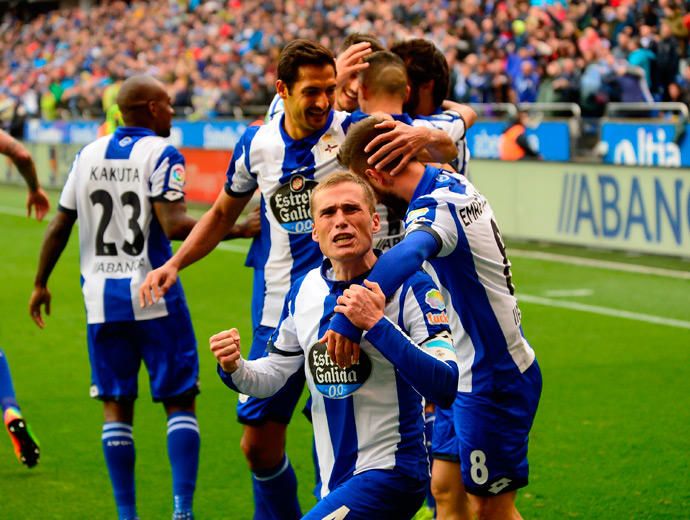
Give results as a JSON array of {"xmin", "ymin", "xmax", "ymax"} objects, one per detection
[{"xmin": 168, "ymin": 412, "xmax": 200, "ymax": 518}]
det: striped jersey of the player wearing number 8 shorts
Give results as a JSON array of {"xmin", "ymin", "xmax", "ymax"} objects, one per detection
[{"xmin": 405, "ymin": 166, "xmax": 535, "ymax": 392}]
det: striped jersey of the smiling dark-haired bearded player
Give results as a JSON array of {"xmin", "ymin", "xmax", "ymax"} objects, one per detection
[{"xmin": 225, "ymin": 111, "xmax": 348, "ymax": 327}]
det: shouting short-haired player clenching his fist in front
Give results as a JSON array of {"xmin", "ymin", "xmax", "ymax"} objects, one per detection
[{"xmin": 210, "ymin": 173, "xmax": 457, "ymax": 520}]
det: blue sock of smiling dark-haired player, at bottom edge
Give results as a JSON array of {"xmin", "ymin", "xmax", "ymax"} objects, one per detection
[{"xmin": 252, "ymin": 455, "xmax": 302, "ymax": 520}]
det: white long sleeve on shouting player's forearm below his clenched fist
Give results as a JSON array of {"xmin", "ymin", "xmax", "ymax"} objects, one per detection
[{"xmin": 218, "ymin": 354, "xmax": 304, "ymax": 398}]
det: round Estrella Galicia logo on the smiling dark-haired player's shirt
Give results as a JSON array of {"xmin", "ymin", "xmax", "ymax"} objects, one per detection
[{"xmin": 270, "ymin": 174, "xmax": 317, "ymax": 234}]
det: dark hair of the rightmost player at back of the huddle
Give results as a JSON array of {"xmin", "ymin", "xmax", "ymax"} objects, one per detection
[{"xmin": 391, "ymin": 38, "xmax": 450, "ymax": 107}]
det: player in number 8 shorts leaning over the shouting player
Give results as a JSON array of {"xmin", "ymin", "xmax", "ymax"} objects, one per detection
[{"xmin": 334, "ymin": 117, "xmax": 541, "ymax": 519}]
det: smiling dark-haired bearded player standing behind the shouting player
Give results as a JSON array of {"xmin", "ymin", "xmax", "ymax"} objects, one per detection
[{"xmin": 140, "ymin": 39, "xmax": 455, "ymax": 520}]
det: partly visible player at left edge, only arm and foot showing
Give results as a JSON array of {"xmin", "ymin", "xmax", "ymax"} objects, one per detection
[{"xmin": 0, "ymin": 130, "xmax": 50, "ymax": 468}]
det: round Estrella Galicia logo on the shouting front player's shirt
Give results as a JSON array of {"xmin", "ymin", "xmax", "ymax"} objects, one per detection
[{"xmin": 309, "ymin": 343, "xmax": 371, "ymax": 399}]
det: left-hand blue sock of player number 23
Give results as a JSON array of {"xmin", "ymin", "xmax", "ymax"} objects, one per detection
[{"xmin": 101, "ymin": 422, "xmax": 137, "ymax": 520}]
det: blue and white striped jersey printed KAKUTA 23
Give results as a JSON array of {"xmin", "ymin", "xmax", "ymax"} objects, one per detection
[{"xmin": 59, "ymin": 127, "xmax": 185, "ymax": 323}]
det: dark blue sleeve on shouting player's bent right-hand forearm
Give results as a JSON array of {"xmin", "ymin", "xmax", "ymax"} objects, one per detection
[{"xmin": 367, "ymin": 317, "xmax": 459, "ymax": 408}]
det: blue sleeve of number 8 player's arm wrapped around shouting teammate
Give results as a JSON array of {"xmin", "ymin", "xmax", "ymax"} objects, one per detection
[{"xmin": 328, "ymin": 228, "xmax": 441, "ymax": 344}]
